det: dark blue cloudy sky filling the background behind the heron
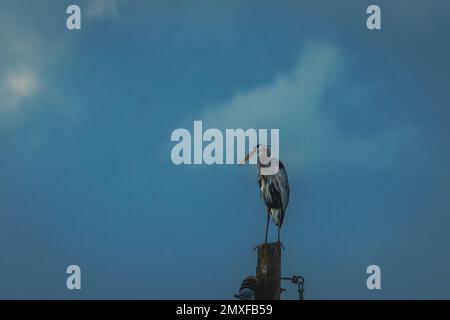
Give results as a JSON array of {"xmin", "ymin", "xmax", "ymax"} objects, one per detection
[{"xmin": 0, "ymin": 0, "xmax": 450, "ymax": 299}]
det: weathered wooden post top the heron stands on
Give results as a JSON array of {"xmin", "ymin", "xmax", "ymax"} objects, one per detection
[{"xmin": 256, "ymin": 242, "xmax": 281, "ymax": 300}]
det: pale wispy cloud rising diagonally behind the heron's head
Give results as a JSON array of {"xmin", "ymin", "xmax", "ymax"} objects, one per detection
[{"xmin": 199, "ymin": 42, "xmax": 412, "ymax": 172}]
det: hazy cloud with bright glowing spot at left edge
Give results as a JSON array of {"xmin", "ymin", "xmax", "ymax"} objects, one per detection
[{"xmin": 0, "ymin": 6, "xmax": 67, "ymax": 149}]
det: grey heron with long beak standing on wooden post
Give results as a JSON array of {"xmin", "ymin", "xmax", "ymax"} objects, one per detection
[{"xmin": 241, "ymin": 144, "xmax": 289, "ymax": 243}]
